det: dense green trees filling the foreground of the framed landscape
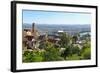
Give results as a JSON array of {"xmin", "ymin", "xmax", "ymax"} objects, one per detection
[{"xmin": 23, "ymin": 33, "xmax": 91, "ymax": 63}]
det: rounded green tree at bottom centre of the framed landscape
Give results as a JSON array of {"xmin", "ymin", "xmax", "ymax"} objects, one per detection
[{"xmin": 44, "ymin": 42, "xmax": 63, "ymax": 61}]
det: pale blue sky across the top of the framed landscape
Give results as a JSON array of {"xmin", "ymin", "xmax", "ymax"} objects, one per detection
[{"xmin": 22, "ymin": 10, "xmax": 91, "ymax": 25}]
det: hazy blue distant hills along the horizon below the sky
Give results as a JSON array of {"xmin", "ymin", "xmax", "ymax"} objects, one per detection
[{"xmin": 23, "ymin": 23, "xmax": 91, "ymax": 32}]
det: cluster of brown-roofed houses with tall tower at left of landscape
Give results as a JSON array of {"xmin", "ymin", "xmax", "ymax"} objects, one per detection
[{"xmin": 23, "ymin": 23, "xmax": 63, "ymax": 49}]
